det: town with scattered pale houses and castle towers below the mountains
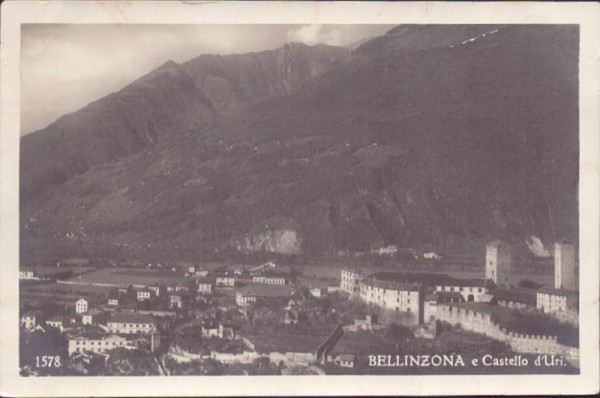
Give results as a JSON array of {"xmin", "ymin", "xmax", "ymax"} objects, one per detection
[{"xmin": 20, "ymin": 240, "xmax": 579, "ymax": 376}]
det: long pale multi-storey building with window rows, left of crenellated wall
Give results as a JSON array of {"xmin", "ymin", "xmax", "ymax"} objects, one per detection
[{"xmin": 360, "ymin": 276, "xmax": 421, "ymax": 320}]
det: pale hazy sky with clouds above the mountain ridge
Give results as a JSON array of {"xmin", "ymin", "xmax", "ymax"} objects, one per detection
[{"xmin": 21, "ymin": 24, "xmax": 391, "ymax": 135}]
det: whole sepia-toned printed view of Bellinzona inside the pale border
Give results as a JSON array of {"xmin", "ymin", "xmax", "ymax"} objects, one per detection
[{"xmin": 0, "ymin": 1, "xmax": 599, "ymax": 396}]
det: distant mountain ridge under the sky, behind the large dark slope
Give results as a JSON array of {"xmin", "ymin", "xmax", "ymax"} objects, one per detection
[{"xmin": 21, "ymin": 43, "xmax": 348, "ymax": 201}]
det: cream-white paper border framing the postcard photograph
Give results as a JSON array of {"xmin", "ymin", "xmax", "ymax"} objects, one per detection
[{"xmin": 0, "ymin": 1, "xmax": 600, "ymax": 396}]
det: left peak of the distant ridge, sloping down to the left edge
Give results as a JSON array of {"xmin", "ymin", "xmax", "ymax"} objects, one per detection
[{"xmin": 20, "ymin": 61, "xmax": 219, "ymax": 202}]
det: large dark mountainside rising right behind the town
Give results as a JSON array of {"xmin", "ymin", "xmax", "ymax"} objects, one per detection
[{"xmin": 22, "ymin": 25, "xmax": 579, "ymax": 262}]
